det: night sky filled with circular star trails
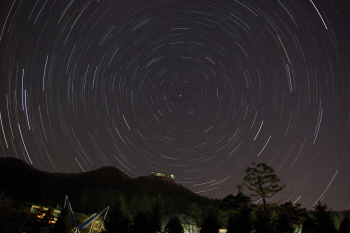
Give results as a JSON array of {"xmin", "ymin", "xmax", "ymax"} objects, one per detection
[{"xmin": 0, "ymin": 0, "xmax": 350, "ymax": 210}]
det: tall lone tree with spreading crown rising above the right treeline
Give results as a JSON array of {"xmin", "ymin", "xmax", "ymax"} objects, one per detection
[{"xmin": 243, "ymin": 163, "xmax": 286, "ymax": 217}]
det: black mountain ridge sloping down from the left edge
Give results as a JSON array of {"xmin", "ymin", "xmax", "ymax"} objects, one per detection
[{"xmin": 0, "ymin": 157, "xmax": 210, "ymax": 212}]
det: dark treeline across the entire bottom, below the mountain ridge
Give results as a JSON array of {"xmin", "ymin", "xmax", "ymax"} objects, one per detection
[{"xmin": 0, "ymin": 187, "xmax": 350, "ymax": 233}]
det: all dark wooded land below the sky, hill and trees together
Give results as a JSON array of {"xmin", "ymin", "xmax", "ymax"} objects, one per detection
[{"xmin": 0, "ymin": 159, "xmax": 350, "ymax": 233}]
